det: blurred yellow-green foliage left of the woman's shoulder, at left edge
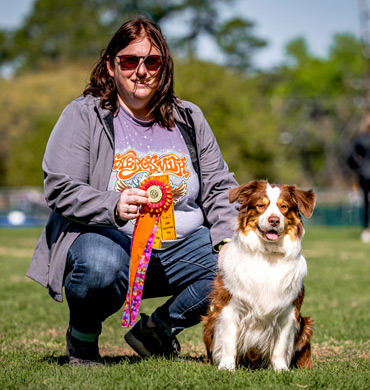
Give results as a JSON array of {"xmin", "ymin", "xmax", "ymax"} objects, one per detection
[{"xmin": 0, "ymin": 64, "xmax": 89, "ymax": 187}]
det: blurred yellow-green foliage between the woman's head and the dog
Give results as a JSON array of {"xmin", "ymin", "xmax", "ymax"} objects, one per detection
[{"xmin": 175, "ymin": 61, "xmax": 282, "ymax": 182}]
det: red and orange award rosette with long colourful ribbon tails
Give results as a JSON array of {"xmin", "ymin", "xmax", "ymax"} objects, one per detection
[{"xmin": 122, "ymin": 174, "xmax": 176, "ymax": 326}]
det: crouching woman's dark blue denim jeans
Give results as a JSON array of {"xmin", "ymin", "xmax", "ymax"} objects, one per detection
[{"xmin": 64, "ymin": 227, "xmax": 218, "ymax": 334}]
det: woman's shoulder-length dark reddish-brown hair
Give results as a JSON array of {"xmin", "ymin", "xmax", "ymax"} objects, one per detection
[{"xmin": 83, "ymin": 18, "xmax": 177, "ymax": 128}]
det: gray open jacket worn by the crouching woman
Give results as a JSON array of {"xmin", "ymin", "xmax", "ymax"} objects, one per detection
[{"xmin": 27, "ymin": 95, "xmax": 238, "ymax": 302}]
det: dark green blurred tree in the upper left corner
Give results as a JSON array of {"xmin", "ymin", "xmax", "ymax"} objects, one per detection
[{"xmin": 1, "ymin": 0, "xmax": 111, "ymax": 68}]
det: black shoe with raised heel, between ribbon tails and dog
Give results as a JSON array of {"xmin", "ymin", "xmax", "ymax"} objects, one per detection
[{"xmin": 125, "ymin": 314, "xmax": 181, "ymax": 360}]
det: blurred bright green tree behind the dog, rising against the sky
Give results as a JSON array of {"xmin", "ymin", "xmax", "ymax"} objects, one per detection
[{"xmin": 270, "ymin": 34, "xmax": 363, "ymax": 185}]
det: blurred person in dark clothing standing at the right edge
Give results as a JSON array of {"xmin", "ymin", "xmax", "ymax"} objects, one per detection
[{"xmin": 348, "ymin": 115, "xmax": 370, "ymax": 243}]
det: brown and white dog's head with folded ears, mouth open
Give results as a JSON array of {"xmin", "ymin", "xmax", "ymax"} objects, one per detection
[{"xmin": 229, "ymin": 180, "xmax": 315, "ymax": 242}]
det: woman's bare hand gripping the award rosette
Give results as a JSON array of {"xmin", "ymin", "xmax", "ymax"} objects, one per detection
[{"xmin": 116, "ymin": 188, "xmax": 149, "ymax": 221}]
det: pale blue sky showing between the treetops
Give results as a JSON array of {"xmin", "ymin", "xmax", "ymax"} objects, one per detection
[{"xmin": 0, "ymin": 0, "xmax": 362, "ymax": 67}]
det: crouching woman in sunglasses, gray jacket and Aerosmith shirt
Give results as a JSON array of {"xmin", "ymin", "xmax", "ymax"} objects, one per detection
[{"xmin": 28, "ymin": 18, "xmax": 237, "ymax": 365}]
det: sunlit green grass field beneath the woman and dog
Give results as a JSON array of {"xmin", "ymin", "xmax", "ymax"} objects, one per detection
[{"xmin": 0, "ymin": 226, "xmax": 370, "ymax": 390}]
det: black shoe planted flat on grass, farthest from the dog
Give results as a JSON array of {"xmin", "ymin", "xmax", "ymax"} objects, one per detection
[{"xmin": 66, "ymin": 328, "xmax": 102, "ymax": 366}]
